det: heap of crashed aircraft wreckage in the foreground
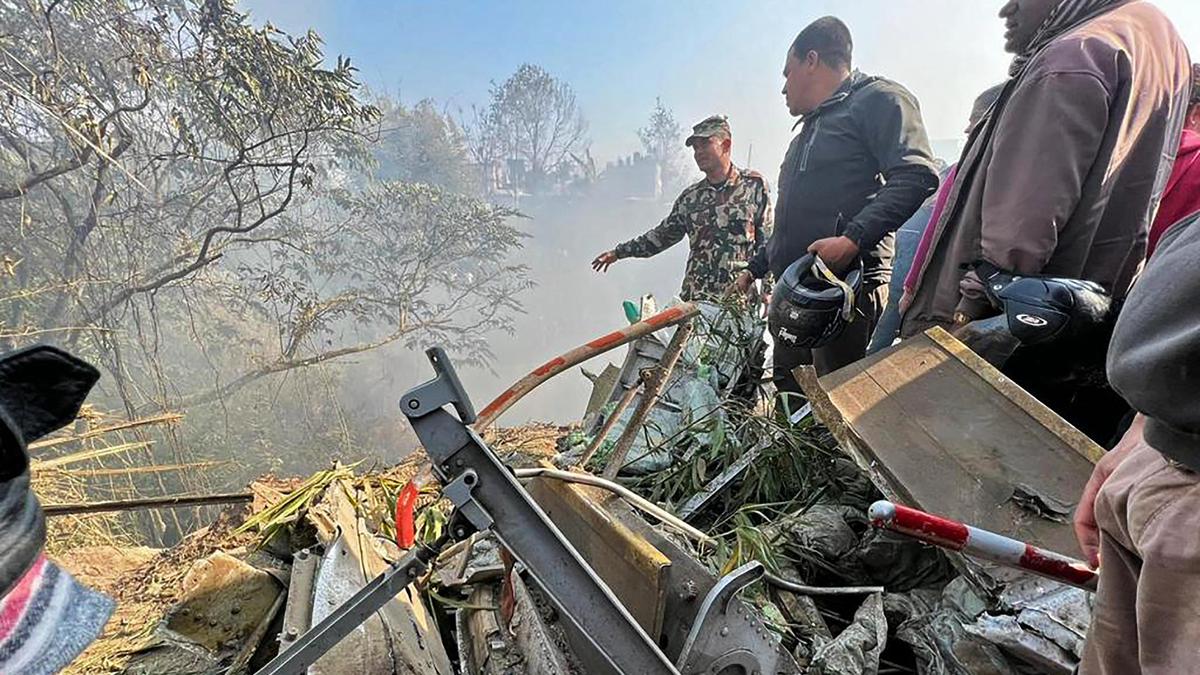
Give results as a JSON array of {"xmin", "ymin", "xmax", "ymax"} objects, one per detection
[{"xmin": 49, "ymin": 303, "xmax": 1096, "ymax": 675}]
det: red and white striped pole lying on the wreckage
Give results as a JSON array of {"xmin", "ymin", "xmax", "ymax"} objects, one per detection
[{"xmin": 866, "ymin": 501, "xmax": 1098, "ymax": 592}]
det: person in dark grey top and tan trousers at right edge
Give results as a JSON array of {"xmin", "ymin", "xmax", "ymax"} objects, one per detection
[{"xmin": 1075, "ymin": 208, "xmax": 1200, "ymax": 675}]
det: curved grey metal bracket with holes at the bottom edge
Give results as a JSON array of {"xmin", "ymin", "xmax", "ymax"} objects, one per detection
[{"xmin": 678, "ymin": 562, "xmax": 798, "ymax": 675}]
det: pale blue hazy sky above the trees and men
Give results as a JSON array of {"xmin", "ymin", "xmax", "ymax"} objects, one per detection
[{"xmin": 245, "ymin": 0, "xmax": 1200, "ymax": 181}]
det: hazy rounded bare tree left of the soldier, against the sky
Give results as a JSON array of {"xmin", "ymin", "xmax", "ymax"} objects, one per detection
[{"xmin": 470, "ymin": 64, "xmax": 588, "ymax": 189}]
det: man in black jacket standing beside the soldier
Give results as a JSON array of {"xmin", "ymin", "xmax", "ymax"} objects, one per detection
[{"xmin": 738, "ymin": 17, "xmax": 937, "ymax": 394}]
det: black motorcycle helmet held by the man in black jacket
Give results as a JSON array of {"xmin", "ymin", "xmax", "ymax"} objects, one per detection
[{"xmin": 767, "ymin": 253, "xmax": 863, "ymax": 350}]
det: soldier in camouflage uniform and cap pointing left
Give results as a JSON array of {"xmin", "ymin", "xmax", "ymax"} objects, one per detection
[{"xmin": 592, "ymin": 115, "xmax": 773, "ymax": 300}]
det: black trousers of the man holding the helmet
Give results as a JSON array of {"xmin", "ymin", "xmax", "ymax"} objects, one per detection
[{"xmin": 770, "ymin": 276, "xmax": 888, "ymax": 411}]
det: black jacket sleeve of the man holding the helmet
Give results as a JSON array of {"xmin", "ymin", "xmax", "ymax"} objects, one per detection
[{"xmin": 845, "ymin": 82, "xmax": 937, "ymax": 251}]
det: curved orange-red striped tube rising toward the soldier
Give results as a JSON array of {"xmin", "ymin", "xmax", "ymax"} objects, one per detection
[{"xmin": 475, "ymin": 303, "xmax": 700, "ymax": 432}]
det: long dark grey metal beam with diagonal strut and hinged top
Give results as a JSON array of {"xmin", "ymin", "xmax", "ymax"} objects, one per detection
[{"xmin": 257, "ymin": 348, "xmax": 679, "ymax": 675}]
